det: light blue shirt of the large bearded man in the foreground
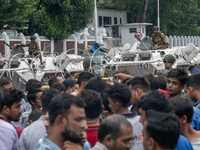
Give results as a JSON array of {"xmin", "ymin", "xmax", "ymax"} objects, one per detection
[{"xmin": 36, "ymin": 137, "xmax": 62, "ymax": 150}]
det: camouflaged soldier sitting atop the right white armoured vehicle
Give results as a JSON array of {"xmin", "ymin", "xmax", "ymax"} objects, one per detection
[{"xmin": 151, "ymin": 26, "xmax": 168, "ymax": 49}]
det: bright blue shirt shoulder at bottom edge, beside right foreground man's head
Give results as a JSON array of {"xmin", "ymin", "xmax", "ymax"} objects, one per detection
[{"xmin": 176, "ymin": 135, "xmax": 193, "ymax": 150}]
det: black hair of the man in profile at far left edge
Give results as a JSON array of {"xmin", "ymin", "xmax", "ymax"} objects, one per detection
[{"xmin": 0, "ymin": 89, "xmax": 24, "ymax": 111}]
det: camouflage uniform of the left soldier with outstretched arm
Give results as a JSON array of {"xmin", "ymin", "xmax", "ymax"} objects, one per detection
[{"xmin": 18, "ymin": 41, "xmax": 40, "ymax": 56}]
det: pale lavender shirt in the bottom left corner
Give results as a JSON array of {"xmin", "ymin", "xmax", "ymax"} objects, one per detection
[{"xmin": 0, "ymin": 119, "xmax": 18, "ymax": 150}]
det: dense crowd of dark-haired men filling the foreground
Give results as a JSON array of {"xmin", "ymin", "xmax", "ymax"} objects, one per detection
[{"xmin": 0, "ymin": 62, "xmax": 200, "ymax": 150}]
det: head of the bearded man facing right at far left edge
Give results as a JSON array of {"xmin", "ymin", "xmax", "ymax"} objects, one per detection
[{"xmin": 0, "ymin": 89, "xmax": 24, "ymax": 121}]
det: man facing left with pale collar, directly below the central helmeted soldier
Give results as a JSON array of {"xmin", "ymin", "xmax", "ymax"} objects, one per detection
[{"xmin": 71, "ymin": 71, "xmax": 95, "ymax": 96}]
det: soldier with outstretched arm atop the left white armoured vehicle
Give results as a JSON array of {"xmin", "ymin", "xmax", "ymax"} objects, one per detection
[{"xmin": 14, "ymin": 36, "xmax": 41, "ymax": 57}]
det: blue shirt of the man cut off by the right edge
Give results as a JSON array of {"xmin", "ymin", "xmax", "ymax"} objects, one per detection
[{"xmin": 191, "ymin": 107, "xmax": 200, "ymax": 131}]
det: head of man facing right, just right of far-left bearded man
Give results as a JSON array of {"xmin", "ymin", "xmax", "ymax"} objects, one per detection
[{"xmin": 27, "ymin": 89, "xmax": 42, "ymax": 109}]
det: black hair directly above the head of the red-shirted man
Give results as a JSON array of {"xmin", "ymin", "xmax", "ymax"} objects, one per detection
[{"xmin": 85, "ymin": 76, "xmax": 106, "ymax": 93}]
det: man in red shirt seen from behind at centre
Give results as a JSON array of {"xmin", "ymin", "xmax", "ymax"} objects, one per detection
[{"xmin": 81, "ymin": 90, "xmax": 103, "ymax": 147}]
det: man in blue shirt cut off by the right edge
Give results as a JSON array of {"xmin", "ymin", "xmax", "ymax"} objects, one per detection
[{"xmin": 184, "ymin": 73, "xmax": 200, "ymax": 131}]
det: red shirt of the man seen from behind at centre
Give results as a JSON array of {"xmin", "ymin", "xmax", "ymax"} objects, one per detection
[{"xmin": 87, "ymin": 125, "xmax": 99, "ymax": 147}]
